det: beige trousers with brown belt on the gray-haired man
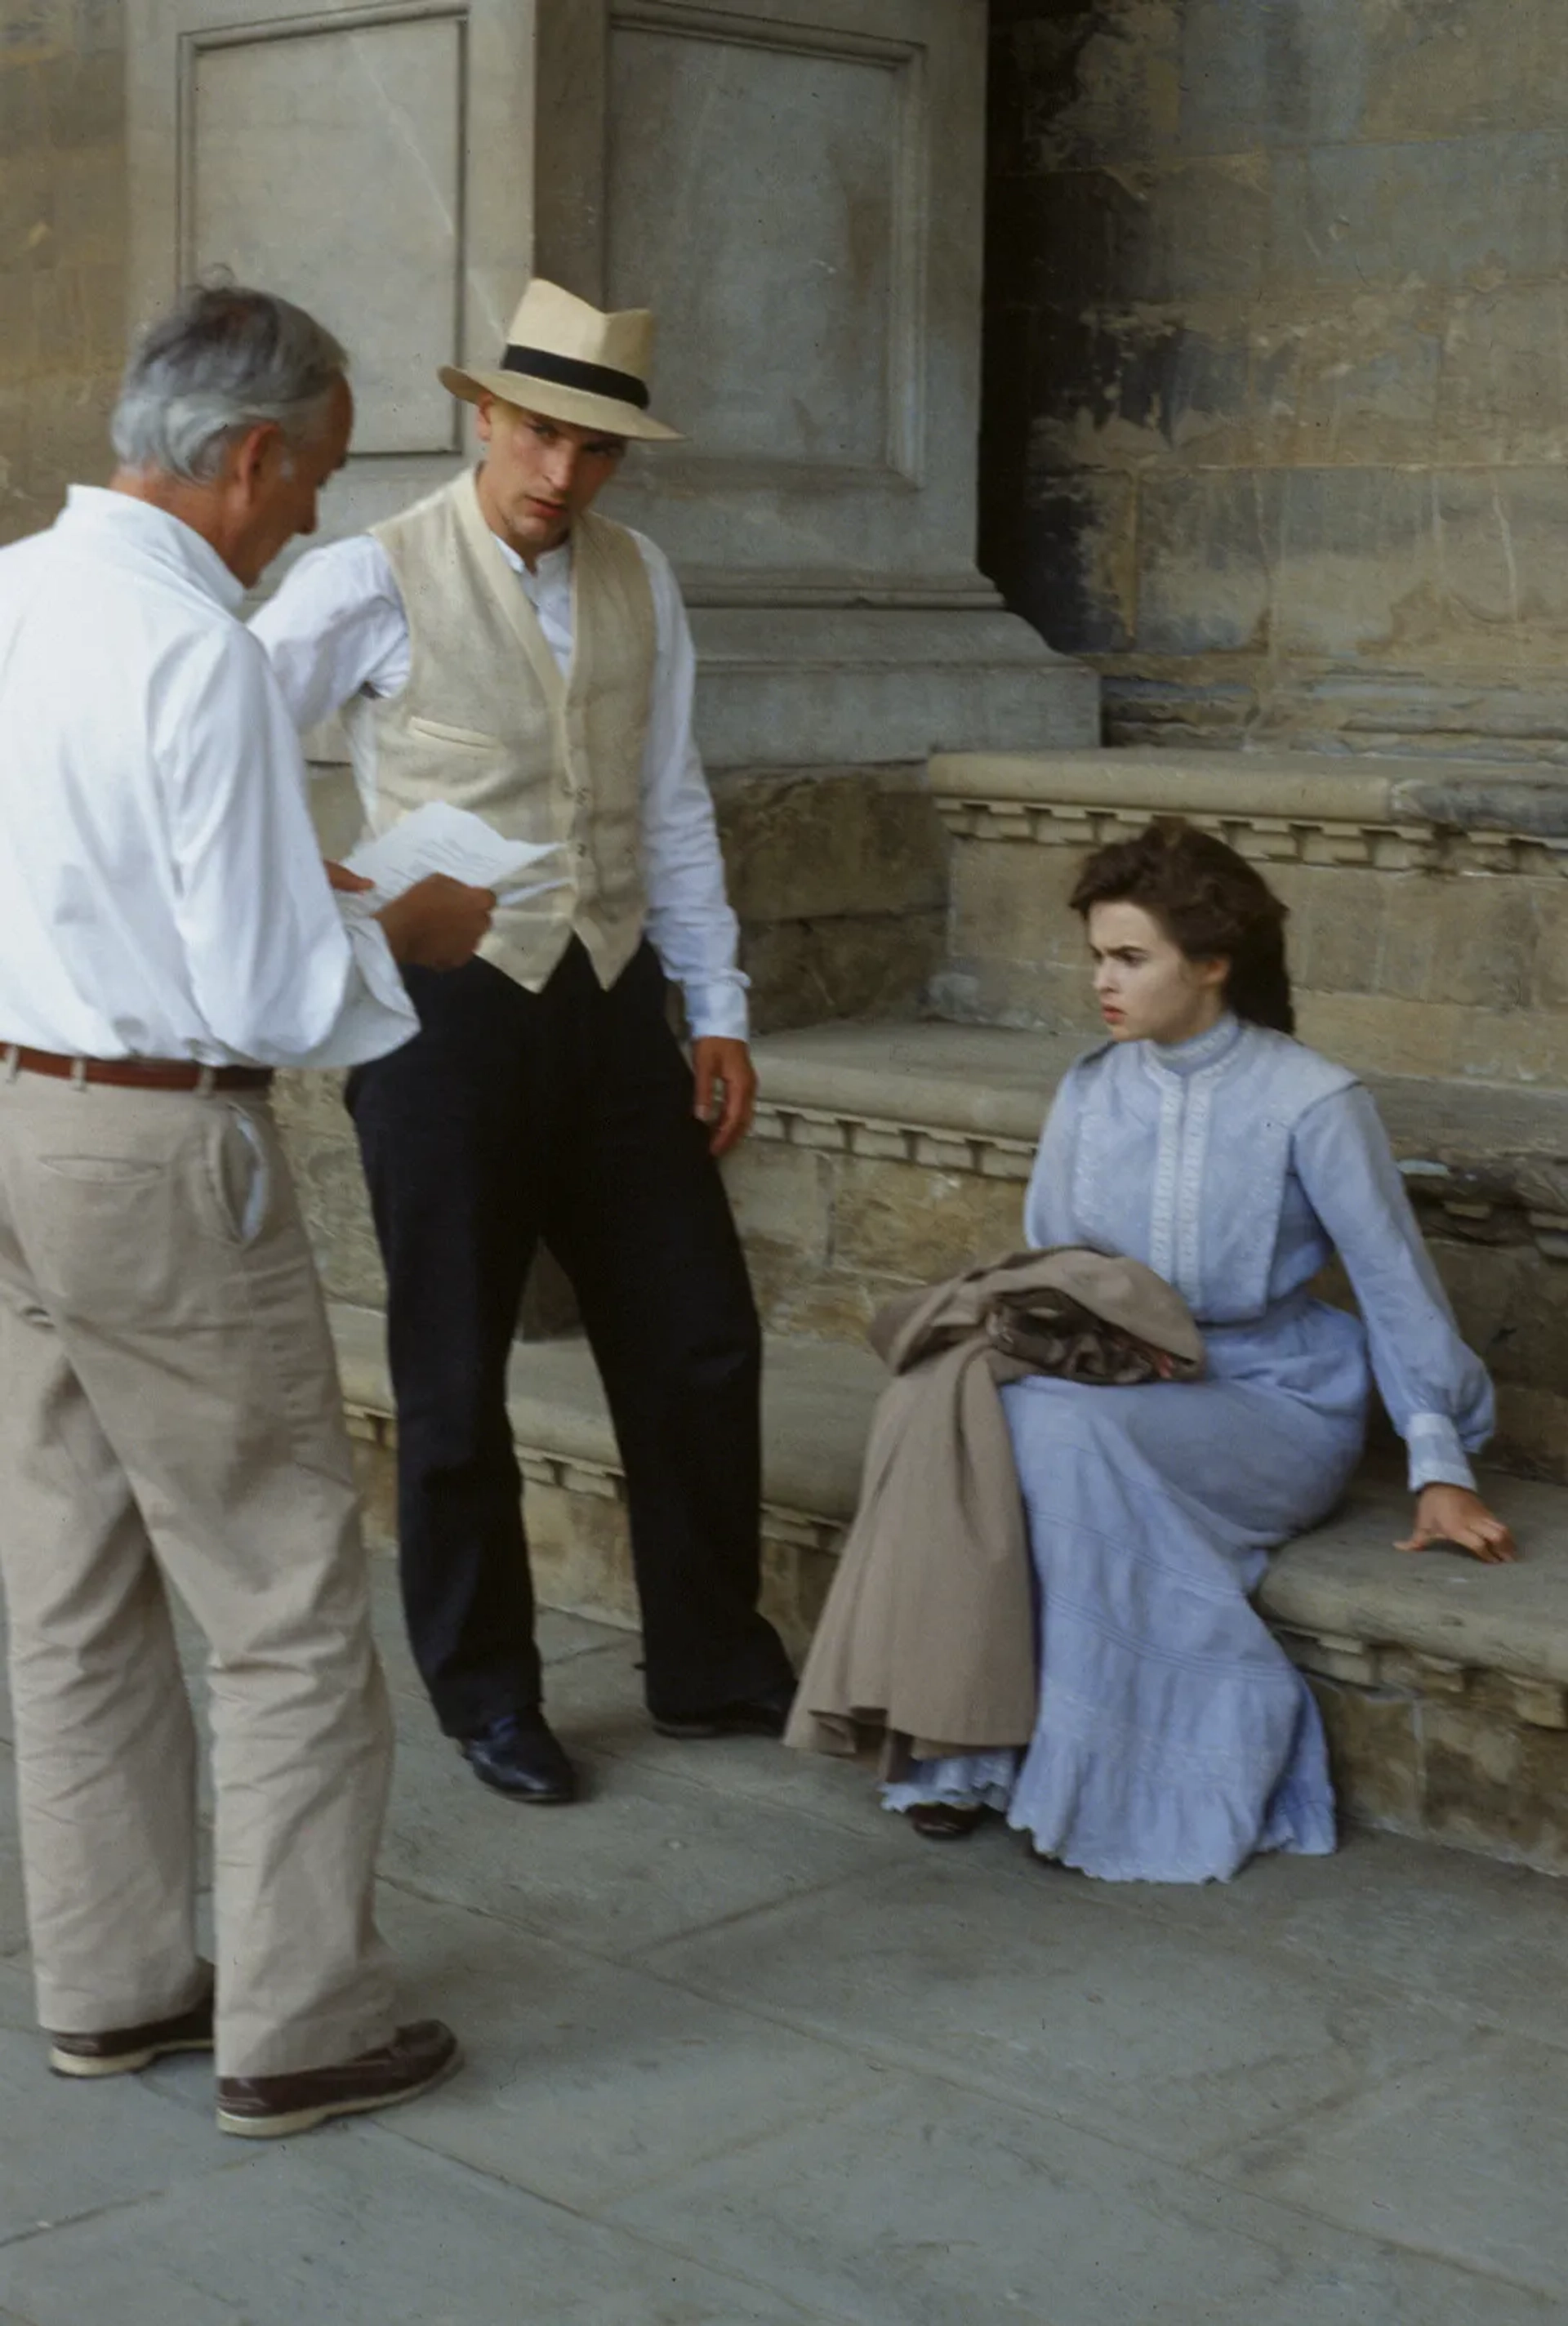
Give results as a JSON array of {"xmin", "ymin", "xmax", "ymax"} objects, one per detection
[{"xmin": 0, "ymin": 1065, "xmax": 393, "ymax": 2074}]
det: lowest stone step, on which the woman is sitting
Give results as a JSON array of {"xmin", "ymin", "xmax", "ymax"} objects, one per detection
[{"xmin": 332, "ymin": 1305, "xmax": 1568, "ymax": 1873}]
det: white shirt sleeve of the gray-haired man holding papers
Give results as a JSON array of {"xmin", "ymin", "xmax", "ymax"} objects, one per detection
[{"xmin": 154, "ymin": 631, "xmax": 419, "ymax": 1065}]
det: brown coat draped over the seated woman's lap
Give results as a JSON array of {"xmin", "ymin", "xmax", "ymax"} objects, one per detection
[{"xmin": 786, "ymin": 1245, "xmax": 1203, "ymax": 1775}]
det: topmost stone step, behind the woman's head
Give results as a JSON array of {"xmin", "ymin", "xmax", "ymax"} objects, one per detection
[{"xmin": 930, "ymin": 751, "xmax": 1568, "ymax": 1084}]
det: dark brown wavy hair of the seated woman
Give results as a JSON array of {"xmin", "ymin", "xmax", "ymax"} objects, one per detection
[{"xmin": 1070, "ymin": 817, "xmax": 1296, "ymax": 1033}]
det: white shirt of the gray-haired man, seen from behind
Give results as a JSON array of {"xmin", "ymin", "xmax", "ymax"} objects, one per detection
[{"xmin": 0, "ymin": 486, "xmax": 419, "ymax": 1065}]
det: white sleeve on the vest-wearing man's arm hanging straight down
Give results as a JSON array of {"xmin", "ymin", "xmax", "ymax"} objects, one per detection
[{"xmin": 638, "ymin": 535, "xmax": 749, "ymax": 1042}]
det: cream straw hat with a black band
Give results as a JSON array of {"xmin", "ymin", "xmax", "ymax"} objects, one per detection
[{"xmin": 439, "ymin": 274, "xmax": 679, "ymax": 442}]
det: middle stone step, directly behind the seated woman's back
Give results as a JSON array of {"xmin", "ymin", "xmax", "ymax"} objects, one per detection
[{"xmin": 728, "ymin": 1021, "xmax": 1568, "ymax": 1477}]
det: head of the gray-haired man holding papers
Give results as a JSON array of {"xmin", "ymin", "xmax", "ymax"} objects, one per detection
[{"xmin": 109, "ymin": 283, "xmax": 354, "ymax": 582}]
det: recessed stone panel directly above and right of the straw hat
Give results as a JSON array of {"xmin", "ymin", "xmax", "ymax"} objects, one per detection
[{"xmin": 608, "ymin": 16, "xmax": 902, "ymax": 470}]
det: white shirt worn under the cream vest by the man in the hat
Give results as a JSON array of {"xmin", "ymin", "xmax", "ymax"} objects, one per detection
[{"xmin": 252, "ymin": 532, "xmax": 746, "ymax": 1042}]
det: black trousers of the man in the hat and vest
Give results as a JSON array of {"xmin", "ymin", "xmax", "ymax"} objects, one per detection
[{"xmin": 349, "ymin": 940, "xmax": 789, "ymax": 1736}]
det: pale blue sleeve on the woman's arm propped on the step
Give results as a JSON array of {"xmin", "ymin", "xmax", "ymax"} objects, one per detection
[{"xmin": 1294, "ymin": 1084, "xmax": 1496, "ymax": 1491}]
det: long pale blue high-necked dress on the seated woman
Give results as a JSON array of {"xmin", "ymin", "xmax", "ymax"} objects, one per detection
[{"xmin": 884, "ymin": 1017, "xmax": 1494, "ymax": 1882}]
